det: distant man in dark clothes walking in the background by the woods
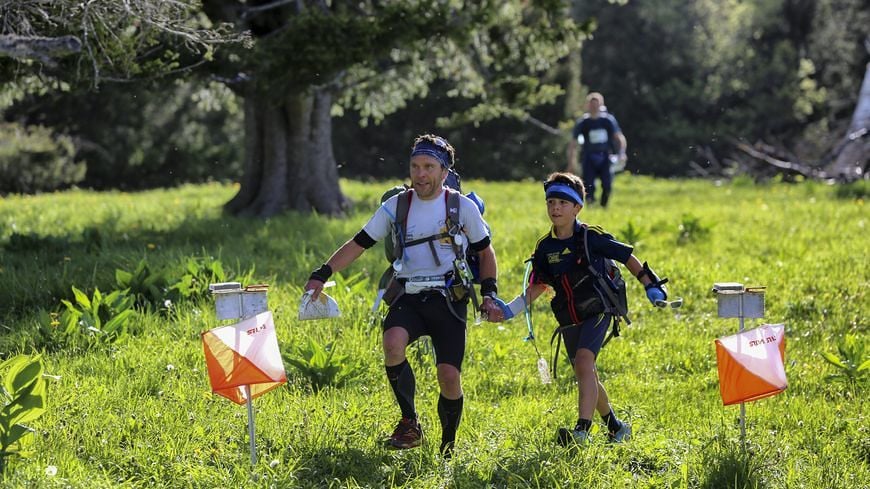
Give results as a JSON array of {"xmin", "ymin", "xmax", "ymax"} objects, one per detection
[{"xmin": 567, "ymin": 92, "xmax": 628, "ymax": 207}]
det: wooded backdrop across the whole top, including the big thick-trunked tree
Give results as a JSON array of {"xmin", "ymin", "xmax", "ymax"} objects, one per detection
[{"xmin": 0, "ymin": 0, "xmax": 870, "ymax": 198}]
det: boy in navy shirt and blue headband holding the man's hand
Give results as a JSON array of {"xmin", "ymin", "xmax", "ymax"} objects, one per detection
[{"xmin": 489, "ymin": 173, "xmax": 667, "ymax": 444}]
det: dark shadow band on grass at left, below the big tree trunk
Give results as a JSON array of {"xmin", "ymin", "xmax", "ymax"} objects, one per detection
[{"xmin": 0, "ymin": 212, "xmax": 362, "ymax": 319}]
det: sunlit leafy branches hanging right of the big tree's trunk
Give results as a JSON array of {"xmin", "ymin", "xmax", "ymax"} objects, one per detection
[{"xmin": 334, "ymin": 1, "xmax": 584, "ymax": 127}]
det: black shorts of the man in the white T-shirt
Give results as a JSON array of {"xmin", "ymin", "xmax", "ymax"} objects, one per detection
[{"xmin": 383, "ymin": 291, "xmax": 467, "ymax": 371}]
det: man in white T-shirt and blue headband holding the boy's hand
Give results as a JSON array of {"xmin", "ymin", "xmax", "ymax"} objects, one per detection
[{"xmin": 305, "ymin": 134, "xmax": 498, "ymax": 457}]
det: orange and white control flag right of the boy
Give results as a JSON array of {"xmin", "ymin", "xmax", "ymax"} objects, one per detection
[{"xmin": 716, "ymin": 324, "xmax": 788, "ymax": 406}]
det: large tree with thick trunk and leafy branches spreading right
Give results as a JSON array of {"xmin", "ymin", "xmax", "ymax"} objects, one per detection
[{"xmin": 199, "ymin": 0, "xmax": 579, "ymax": 215}]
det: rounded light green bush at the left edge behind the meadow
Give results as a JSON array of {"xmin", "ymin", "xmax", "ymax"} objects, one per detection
[{"xmin": 0, "ymin": 123, "xmax": 85, "ymax": 195}]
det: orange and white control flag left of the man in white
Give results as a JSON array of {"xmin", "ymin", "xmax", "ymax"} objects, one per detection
[{"xmin": 202, "ymin": 311, "xmax": 287, "ymax": 404}]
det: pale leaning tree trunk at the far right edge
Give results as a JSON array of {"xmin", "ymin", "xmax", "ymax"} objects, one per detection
[{"xmin": 828, "ymin": 63, "xmax": 870, "ymax": 181}]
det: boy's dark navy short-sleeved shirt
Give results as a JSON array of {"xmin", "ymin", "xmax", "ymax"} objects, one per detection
[{"xmin": 532, "ymin": 221, "xmax": 634, "ymax": 326}]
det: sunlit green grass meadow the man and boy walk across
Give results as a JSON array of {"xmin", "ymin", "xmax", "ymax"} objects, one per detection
[{"xmin": 0, "ymin": 176, "xmax": 870, "ymax": 488}]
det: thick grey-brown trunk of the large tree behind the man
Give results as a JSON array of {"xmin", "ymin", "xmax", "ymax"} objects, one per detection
[{"xmin": 225, "ymin": 89, "xmax": 348, "ymax": 217}]
